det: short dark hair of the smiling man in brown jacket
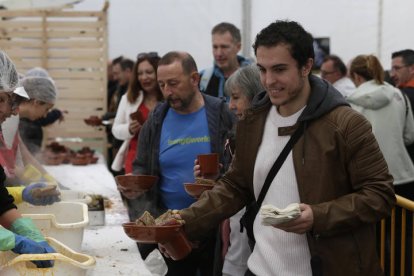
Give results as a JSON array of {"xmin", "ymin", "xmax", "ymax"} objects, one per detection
[{"xmin": 253, "ymin": 20, "xmax": 315, "ymax": 68}]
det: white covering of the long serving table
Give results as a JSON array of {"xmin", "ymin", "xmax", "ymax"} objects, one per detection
[{"xmin": 45, "ymin": 162, "xmax": 151, "ymax": 276}]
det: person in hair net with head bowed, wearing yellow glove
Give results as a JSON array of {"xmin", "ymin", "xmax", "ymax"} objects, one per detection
[{"xmin": 0, "ymin": 68, "xmax": 60, "ymax": 205}]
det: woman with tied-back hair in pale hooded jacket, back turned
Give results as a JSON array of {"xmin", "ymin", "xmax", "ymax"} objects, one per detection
[{"xmin": 347, "ymin": 55, "xmax": 414, "ymax": 194}]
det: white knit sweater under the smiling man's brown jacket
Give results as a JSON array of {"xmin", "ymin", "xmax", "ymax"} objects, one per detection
[{"xmin": 248, "ymin": 106, "xmax": 312, "ymax": 276}]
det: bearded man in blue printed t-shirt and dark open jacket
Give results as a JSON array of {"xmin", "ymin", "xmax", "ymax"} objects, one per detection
[{"xmin": 133, "ymin": 52, "xmax": 235, "ymax": 276}]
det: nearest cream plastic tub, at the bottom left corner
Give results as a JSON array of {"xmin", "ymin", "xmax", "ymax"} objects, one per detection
[{"xmin": 0, "ymin": 237, "xmax": 96, "ymax": 276}]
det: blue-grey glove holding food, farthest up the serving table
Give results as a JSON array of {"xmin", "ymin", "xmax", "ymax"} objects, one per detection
[{"xmin": 22, "ymin": 183, "xmax": 60, "ymax": 205}]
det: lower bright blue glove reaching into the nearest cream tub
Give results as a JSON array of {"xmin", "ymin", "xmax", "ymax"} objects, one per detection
[{"xmin": 12, "ymin": 234, "xmax": 56, "ymax": 268}]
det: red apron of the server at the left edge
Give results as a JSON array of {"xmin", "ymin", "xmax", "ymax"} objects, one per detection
[{"xmin": 0, "ymin": 131, "xmax": 20, "ymax": 178}]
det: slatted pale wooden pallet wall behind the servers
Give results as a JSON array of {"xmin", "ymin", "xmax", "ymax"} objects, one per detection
[{"xmin": 0, "ymin": 7, "xmax": 108, "ymax": 155}]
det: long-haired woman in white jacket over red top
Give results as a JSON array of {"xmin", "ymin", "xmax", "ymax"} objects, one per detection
[{"xmin": 111, "ymin": 52, "xmax": 162, "ymax": 177}]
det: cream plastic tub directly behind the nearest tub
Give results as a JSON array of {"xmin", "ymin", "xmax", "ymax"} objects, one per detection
[{"xmin": 17, "ymin": 202, "xmax": 89, "ymax": 251}]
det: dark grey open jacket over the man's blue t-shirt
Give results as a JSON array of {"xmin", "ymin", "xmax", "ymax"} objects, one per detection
[{"xmin": 129, "ymin": 94, "xmax": 236, "ymax": 219}]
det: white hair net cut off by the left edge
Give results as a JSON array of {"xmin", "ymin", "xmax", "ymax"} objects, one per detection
[{"xmin": 0, "ymin": 50, "xmax": 19, "ymax": 92}]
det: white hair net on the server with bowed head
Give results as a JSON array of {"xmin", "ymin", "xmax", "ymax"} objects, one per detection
[{"xmin": 21, "ymin": 67, "xmax": 57, "ymax": 104}]
